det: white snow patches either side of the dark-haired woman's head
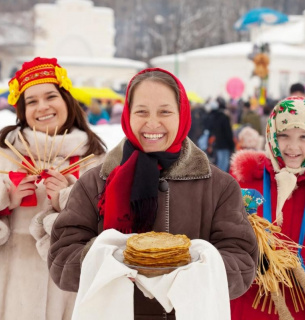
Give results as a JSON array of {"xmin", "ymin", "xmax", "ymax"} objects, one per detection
[{"xmin": 0, "ymin": 110, "xmax": 125, "ymax": 151}]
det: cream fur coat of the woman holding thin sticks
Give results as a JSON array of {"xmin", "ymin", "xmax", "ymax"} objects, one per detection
[{"xmin": 0, "ymin": 128, "xmax": 102, "ymax": 320}]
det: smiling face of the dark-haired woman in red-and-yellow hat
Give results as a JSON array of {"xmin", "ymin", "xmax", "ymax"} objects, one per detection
[{"xmin": 24, "ymin": 83, "xmax": 68, "ymax": 135}]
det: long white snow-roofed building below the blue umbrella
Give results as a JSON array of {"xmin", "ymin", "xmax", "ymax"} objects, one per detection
[{"xmin": 151, "ymin": 13, "xmax": 305, "ymax": 99}]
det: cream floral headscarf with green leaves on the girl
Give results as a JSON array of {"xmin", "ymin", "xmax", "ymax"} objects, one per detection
[{"xmin": 266, "ymin": 96, "xmax": 305, "ymax": 225}]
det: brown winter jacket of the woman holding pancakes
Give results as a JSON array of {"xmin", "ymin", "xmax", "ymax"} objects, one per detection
[{"xmin": 48, "ymin": 138, "xmax": 258, "ymax": 320}]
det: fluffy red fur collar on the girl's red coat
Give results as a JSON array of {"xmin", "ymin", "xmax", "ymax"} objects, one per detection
[{"xmin": 230, "ymin": 150, "xmax": 266, "ymax": 182}]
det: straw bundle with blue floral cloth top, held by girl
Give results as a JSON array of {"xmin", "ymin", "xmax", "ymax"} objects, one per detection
[{"xmin": 242, "ymin": 189, "xmax": 305, "ymax": 320}]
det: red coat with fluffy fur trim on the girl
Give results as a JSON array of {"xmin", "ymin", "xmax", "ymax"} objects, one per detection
[{"xmin": 231, "ymin": 150, "xmax": 305, "ymax": 320}]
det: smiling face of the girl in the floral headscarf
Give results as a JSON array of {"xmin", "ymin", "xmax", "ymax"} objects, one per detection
[{"xmin": 277, "ymin": 128, "xmax": 305, "ymax": 169}]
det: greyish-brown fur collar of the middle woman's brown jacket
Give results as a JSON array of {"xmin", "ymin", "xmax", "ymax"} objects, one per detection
[{"xmin": 100, "ymin": 138, "xmax": 211, "ymax": 180}]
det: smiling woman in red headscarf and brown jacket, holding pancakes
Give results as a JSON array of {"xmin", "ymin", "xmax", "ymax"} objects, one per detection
[{"xmin": 48, "ymin": 68, "xmax": 257, "ymax": 319}]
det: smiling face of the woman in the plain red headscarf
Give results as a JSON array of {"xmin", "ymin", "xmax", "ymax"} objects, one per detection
[{"xmin": 130, "ymin": 80, "xmax": 179, "ymax": 152}]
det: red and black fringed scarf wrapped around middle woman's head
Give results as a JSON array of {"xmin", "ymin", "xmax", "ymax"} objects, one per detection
[{"xmin": 98, "ymin": 68, "xmax": 191, "ymax": 233}]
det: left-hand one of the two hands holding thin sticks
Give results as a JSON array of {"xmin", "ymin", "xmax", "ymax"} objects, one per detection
[{"xmin": 7, "ymin": 175, "xmax": 38, "ymax": 210}]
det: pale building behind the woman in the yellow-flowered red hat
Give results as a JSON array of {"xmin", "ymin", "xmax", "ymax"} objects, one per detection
[{"xmin": 0, "ymin": 0, "xmax": 146, "ymax": 89}]
